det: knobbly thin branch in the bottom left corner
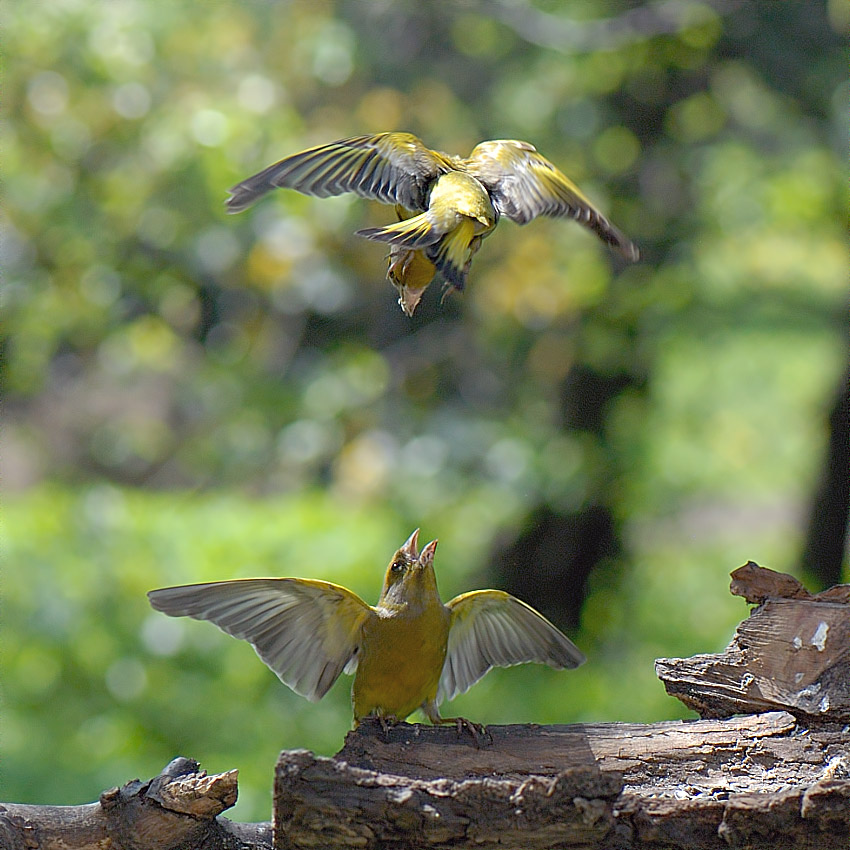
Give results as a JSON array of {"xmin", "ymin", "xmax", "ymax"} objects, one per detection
[{"xmin": 0, "ymin": 758, "xmax": 271, "ymax": 850}]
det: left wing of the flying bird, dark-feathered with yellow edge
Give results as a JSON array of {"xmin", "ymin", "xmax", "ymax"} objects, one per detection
[{"xmin": 225, "ymin": 133, "xmax": 454, "ymax": 213}]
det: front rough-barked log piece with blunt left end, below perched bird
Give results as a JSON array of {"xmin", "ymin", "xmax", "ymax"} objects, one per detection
[{"xmin": 275, "ymin": 744, "xmax": 620, "ymax": 850}]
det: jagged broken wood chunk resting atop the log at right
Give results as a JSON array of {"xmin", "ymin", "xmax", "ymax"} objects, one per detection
[{"xmin": 655, "ymin": 562, "xmax": 850, "ymax": 722}]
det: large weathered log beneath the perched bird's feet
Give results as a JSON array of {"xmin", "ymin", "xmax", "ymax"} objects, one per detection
[{"xmin": 275, "ymin": 712, "xmax": 850, "ymax": 850}]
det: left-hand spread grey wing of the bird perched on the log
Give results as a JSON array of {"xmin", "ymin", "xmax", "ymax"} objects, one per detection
[{"xmin": 148, "ymin": 578, "xmax": 375, "ymax": 702}]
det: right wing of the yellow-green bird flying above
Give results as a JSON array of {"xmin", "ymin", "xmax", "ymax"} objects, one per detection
[{"xmin": 464, "ymin": 139, "xmax": 640, "ymax": 262}]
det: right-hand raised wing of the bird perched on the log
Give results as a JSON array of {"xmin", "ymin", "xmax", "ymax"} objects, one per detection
[{"xmin": 437, "ymin": 590, "xmax": 585, "ymax": 705}]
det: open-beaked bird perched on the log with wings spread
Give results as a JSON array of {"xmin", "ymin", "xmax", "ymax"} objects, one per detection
[{"xmin": 148, "ymin": 529, "xmax": 585, "ymax": 726}]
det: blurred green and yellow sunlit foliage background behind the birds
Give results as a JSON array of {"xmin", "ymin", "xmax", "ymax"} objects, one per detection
[{"xmin": 0, "ymin": 0, "xmax": 850, "ymax": 820}]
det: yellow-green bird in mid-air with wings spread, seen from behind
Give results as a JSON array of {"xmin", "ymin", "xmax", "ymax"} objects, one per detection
[{"xmin": 225, "ymin": 132, "xmax": 640, "ymax": 316}]
